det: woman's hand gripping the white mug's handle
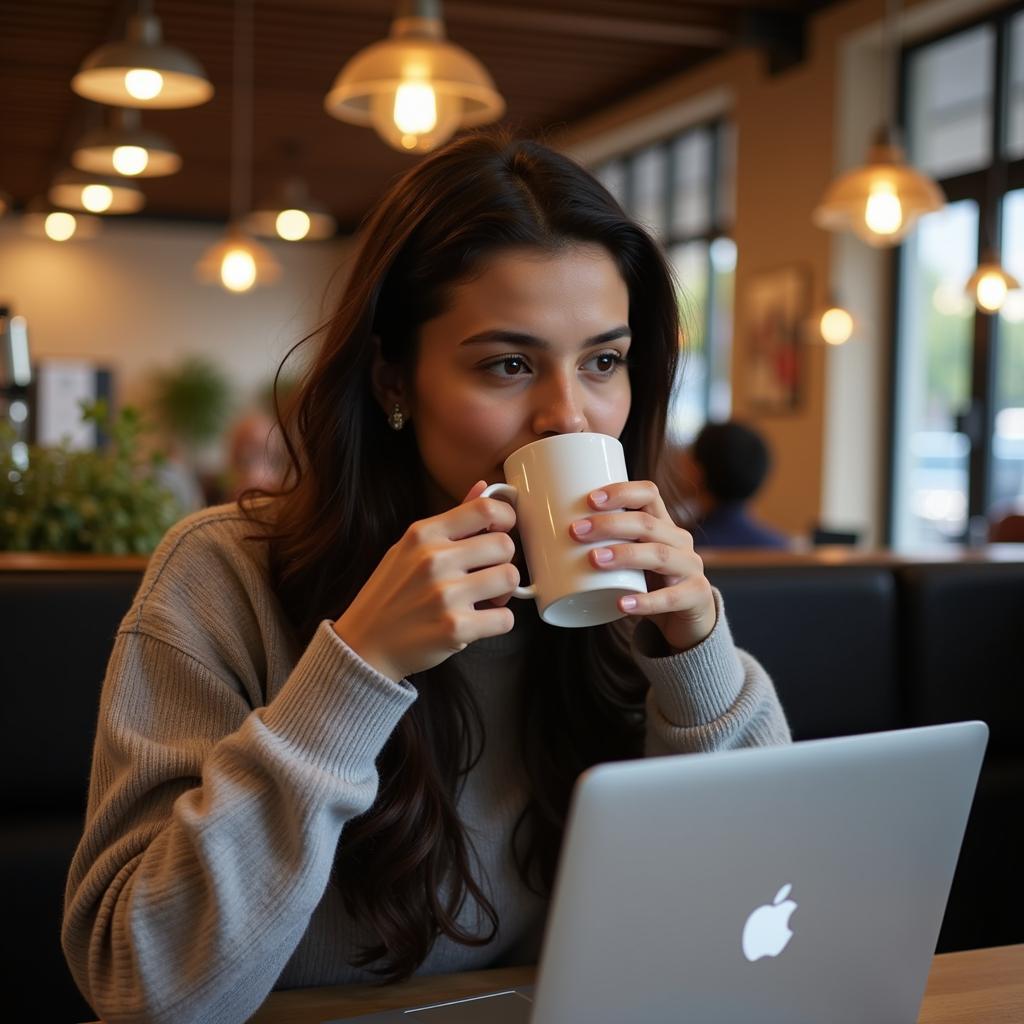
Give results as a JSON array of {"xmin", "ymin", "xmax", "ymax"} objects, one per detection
[{"xmin": 334, "ymin": 480, "xmax": 519, "ymax": 681}]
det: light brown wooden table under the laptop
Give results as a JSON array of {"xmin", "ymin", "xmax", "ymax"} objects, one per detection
[{"xmin": 250, "ymin": 945, "xmax": 1024, "ymax": 1024}]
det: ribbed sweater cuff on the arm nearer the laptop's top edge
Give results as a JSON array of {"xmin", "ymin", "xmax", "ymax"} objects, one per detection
[{"xmin": 633, "ymin": 590, "xmax": 743, "ymax": 728}]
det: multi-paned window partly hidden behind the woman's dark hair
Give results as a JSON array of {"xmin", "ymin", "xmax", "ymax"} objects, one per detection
[{"xmin": 595, "ymin": 121, "xmax": 736, "ymax": 443}]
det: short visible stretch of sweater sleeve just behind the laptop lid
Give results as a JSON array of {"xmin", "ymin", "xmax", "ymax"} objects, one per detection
[{"xmin": 633, "ymin": 590, "xmax": 790, "ymax": 756}]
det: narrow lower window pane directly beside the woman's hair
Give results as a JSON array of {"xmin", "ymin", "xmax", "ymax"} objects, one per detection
[{"xmin": 668, "ymin": 242, "xmax": 709, "ymax": 444}]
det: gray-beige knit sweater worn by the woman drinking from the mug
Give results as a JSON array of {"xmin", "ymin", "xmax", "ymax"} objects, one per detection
[{"xmin": 63, "ymin": 506, "xmax": 788, "ymax": 1024}]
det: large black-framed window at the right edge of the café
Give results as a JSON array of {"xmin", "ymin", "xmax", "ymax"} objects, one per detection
[{"xmin": 889, "ymin": 10, "xmax": 1024, "ymax": 549}]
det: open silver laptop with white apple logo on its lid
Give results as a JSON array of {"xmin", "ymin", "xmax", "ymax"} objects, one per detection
[{"xmin": 327, "ymin": 722, "xmax": 988, "ymax": 1024}]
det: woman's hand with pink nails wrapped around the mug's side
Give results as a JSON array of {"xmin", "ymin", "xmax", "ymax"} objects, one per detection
[{"xmin": 569, "ymin": 480, "xmax": 717, "ymax": 650}]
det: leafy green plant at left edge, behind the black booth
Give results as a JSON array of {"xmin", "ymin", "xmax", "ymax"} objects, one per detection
[{"xmin": 0, "ymin": 401, "xmax": 181, "ymax": 555}]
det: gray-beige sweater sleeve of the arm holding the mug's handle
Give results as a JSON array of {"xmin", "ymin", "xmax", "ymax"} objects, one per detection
[{"xmin": 62, "ymin": 622, "xmax": 416, "ymax": 1024}]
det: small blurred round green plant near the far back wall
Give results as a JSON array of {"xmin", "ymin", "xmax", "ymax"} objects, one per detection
[{"xmin": 154, "ymin": 355, "xmax": 230, "ymax": 449}]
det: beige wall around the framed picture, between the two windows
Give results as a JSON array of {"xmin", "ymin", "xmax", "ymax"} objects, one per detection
[{"xmin": 558, "ymin": 0, "xmax": 994, "ymax": 540}]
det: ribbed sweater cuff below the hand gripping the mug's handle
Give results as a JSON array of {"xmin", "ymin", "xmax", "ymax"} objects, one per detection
[{"xmin": 258, "ymin": 621, "xmax": 416, "ymax": 775}]
